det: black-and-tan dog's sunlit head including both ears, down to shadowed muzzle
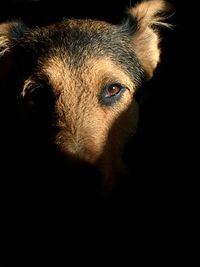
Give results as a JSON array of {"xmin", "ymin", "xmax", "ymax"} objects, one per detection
[{"xmin": 0, "ymin": 0, "xmax": 172, "ymax": 188}]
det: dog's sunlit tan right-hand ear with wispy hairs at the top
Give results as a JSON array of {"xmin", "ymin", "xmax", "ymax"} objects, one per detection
[{"xmin": 124, "ymin": 0, "xmax": 172, "ymax": 79}]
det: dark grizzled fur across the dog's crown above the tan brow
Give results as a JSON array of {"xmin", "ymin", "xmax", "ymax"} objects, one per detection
[{"xmin": 22, "ymin": 20, "xmax": 142, "ymax": 86}]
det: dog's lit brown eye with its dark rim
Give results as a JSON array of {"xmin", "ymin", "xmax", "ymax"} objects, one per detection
[{"xmin": 100, "ymin": 83, "xmax": 126, "ymax": 105}]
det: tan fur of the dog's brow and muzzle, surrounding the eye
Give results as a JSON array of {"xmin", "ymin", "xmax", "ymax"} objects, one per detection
[{"xmin": 27, "ymin": 57, "xmax": 137, "ymax": 182}]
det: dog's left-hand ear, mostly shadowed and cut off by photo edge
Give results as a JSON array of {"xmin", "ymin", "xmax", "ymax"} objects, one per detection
[{"xmin": 0, "ymin": 21, "xmax": 28, "ymax": 79}]
